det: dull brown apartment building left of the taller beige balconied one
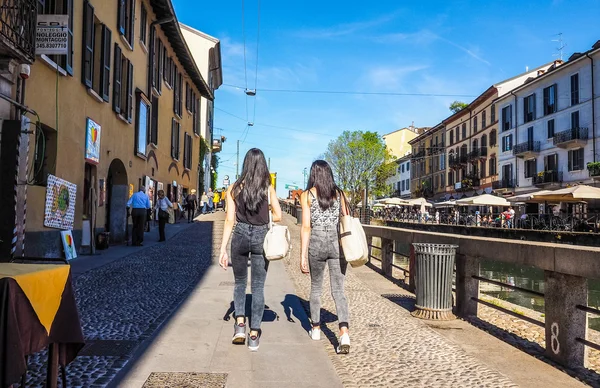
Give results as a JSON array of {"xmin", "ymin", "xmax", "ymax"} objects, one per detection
[{"xmin": 409, "ymin": 123, "xmax": 446, "ymax": 200}]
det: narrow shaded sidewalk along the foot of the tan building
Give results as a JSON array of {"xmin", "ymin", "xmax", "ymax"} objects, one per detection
[{"xmin": 69, "ymin": 220, "xmax": 193, "ymax": 278}]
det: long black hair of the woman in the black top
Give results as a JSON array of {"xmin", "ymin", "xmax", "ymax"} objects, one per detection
[{"xmin": 232, "ymin": 148, "xmax": 271, "ymax": 213}]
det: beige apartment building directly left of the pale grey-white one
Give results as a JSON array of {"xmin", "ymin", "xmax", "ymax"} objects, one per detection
[{"xmin": 443, "ymin": 65, "xmax": 548, "ymax": 199}]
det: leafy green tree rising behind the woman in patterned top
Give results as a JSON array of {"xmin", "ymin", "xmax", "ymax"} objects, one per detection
[{"xmin": 324, "ymin": 131, "xmax": 396, "ymax": 208}]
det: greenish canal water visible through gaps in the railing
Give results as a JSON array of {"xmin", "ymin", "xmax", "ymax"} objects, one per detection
[{"xmin": 394, "ymin": 255, "xmax": 600, "ymax": 331}]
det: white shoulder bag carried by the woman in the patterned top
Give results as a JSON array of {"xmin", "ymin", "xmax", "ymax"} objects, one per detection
[{"xmin": 340, "ymin": 197, "xmax": 369, "ymax": 267}]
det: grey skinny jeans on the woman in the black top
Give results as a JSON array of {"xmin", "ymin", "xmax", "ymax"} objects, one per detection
[{"xmin": 231, "ymin": 222, "xmax": 269, "ymax": 331}]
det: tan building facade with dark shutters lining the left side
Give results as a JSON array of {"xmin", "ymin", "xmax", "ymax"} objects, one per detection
[{"xmin": 0, "ymin": 0, "xmax": 214, "ymax": 257}]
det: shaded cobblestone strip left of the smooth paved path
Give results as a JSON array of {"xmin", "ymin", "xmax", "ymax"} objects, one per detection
[{"xmin": 27, "ymin": 222, "xmax": 213, "ymax": 387}]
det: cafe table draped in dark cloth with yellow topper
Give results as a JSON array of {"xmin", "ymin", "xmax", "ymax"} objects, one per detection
[{"xmin": 0, "ymin": 263, "xmax": 84, "ymax": 388}]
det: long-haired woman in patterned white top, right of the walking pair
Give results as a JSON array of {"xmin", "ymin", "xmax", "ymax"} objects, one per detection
[{"xmin": 300, "ymin": 160, "xmax": 350, "ymax": 354}]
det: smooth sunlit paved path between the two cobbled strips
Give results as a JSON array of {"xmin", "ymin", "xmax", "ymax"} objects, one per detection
[{"xmin": 116, "ymin": 212, "xmax": 342, "ymax": 388}]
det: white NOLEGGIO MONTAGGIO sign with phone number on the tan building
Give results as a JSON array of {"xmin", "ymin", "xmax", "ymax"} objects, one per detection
[{"xmin": 35, "ymin": 15, "xmax": 69, "ymax": 55}]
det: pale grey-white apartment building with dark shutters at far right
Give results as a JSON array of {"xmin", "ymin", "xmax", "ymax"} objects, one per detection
[{"xmin": 496, "ymin": 41, "xmax": 600, "ymax": 193}]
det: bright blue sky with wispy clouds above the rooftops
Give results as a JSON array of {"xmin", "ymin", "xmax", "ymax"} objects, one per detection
[{"xmin": 173, "ymin": 0, "xmax": 600, "ymax": 196}]
